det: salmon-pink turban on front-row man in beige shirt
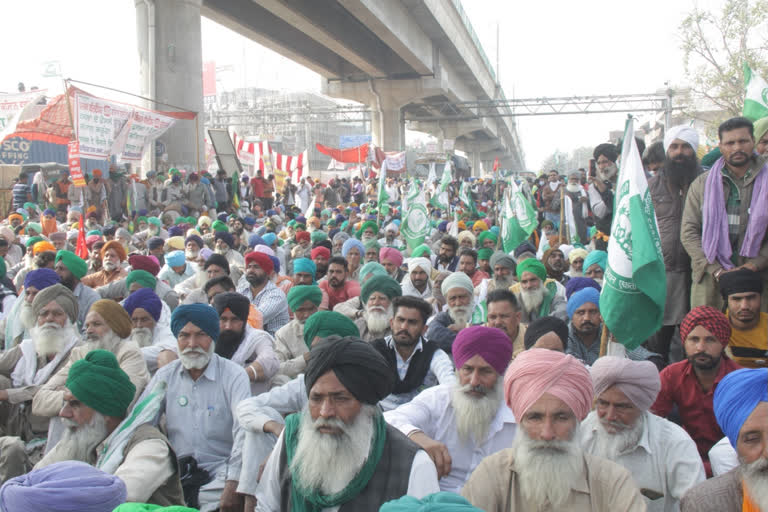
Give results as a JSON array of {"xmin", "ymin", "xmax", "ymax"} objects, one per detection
[{"xmin": 504, "ymin": 348, "xmax": 593, "ymax": 421}]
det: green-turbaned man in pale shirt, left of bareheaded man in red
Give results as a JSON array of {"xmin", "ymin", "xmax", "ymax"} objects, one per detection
[{"xmin": 272, "ymin": 284, "xmax": 323, "ymax": 387}]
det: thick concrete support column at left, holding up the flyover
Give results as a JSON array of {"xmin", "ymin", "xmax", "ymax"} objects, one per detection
[{"xmin": 135, "ymin": 0, "xmax": 205, "ymax": 170}]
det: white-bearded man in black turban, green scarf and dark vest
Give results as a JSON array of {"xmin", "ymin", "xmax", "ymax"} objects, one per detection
[{"xmin": 256, "ymin": 336, "xmax": 439, "ymax": 512}]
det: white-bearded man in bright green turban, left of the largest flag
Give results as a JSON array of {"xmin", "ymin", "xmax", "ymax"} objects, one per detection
[{"xmin": 510, "ymin": 258, "xmax": 568, "ymax": 325}]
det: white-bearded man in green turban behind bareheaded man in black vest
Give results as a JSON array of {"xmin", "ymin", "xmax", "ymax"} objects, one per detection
[{"xmin": 355, "ymin": 275, "xmax": 403, "ymax": 341}]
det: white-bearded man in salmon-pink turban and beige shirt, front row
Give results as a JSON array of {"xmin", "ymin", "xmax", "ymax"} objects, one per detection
[{"xmin": 461, "ymin": 348, "xmax": 646, "ymax": 512}]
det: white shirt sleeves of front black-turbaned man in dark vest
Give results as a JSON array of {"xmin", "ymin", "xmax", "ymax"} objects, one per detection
[{"xmin": 254, "ymin": 428, "xmax": 440, "ymax": 512}]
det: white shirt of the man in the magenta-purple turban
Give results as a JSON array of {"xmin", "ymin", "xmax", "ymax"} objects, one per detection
[{"xmin": 384, "ymin": 384, "xmax": 517, "ymax": 493}]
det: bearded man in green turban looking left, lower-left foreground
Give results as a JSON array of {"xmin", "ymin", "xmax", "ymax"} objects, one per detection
[{"xmin": 35, "ymin": 350, "xmax": 184, "ymax": 506}]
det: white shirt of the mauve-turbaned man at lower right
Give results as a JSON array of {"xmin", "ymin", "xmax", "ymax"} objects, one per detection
[{"xmin": 580, "ymin": 411, "xmax": 705, "ymax": 512}]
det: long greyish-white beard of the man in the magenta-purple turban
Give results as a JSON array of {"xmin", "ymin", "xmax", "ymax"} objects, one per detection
[{"xmin": 451, "ymin": 371, "xmax": 504, "ymax": 445}]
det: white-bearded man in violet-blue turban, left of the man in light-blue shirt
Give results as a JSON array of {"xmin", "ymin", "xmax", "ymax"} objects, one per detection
[{"xmin": 123, "ymin": 288, "xmax": 178, "ymax": 375}]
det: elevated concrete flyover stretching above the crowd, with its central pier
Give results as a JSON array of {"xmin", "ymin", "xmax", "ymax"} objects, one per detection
[{"xmin": 136, "ymin": 0, "xmax": 525, "ymax": 169}]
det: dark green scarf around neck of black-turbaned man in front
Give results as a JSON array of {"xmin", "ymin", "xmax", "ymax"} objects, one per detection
[{"xmin": 284, "ymin": 413, "xmax": 387, "ymax": 512}]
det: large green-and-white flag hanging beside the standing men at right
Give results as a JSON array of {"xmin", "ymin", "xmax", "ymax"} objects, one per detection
[{"xmin": 600, "ymin": 119, "xmax": 667, "ymax": 350}]
